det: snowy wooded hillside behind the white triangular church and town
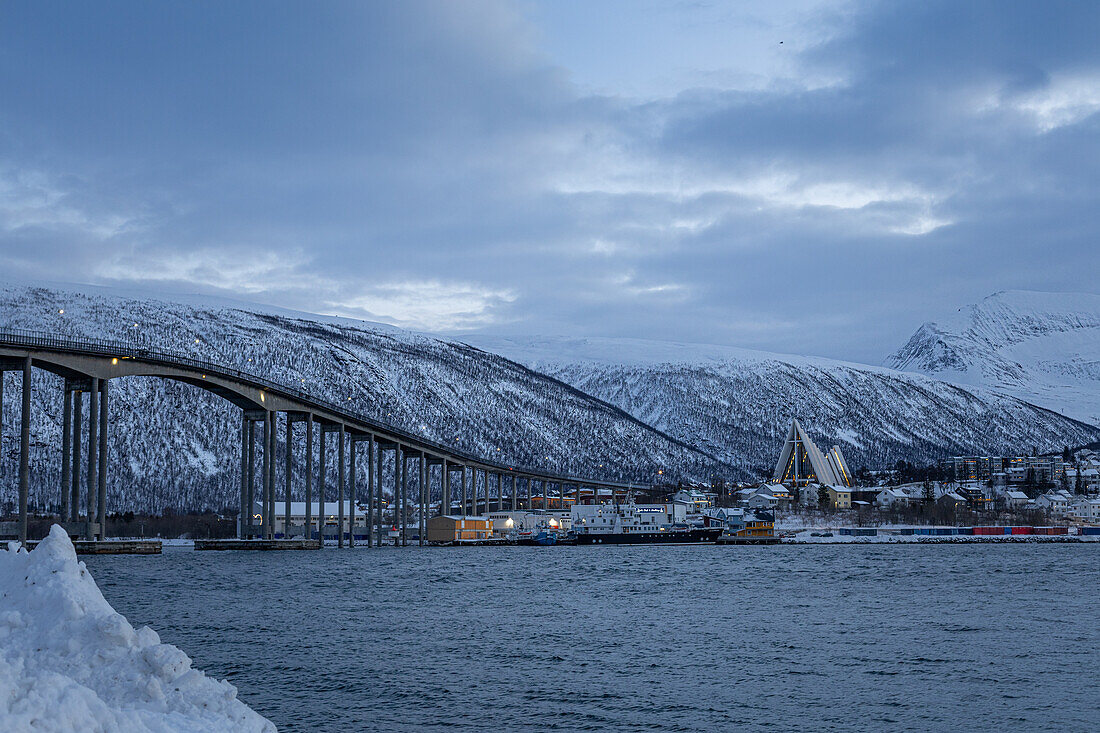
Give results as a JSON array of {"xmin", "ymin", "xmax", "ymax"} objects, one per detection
[{"xmin": 466, "ymin": 336, "xmax": 1100, "ymax": 469}]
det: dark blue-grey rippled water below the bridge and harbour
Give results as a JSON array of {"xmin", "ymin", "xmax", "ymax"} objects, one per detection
[{"xmin": 87, "ymin": 545, "xmax": 1100, "ymax": 731}]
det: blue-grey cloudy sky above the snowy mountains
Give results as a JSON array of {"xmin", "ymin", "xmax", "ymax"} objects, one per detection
[{"xmin": 0, "ymin": 0, "xmax": 1100, "ymax": 363}]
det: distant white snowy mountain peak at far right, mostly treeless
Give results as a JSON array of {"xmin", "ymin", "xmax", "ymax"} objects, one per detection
[{"xmin": 887, "ymin": 291, "xmax": 1100, "ymax": 424}]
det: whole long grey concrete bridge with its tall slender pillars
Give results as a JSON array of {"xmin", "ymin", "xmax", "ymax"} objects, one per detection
[{"xmin": 0, "ymin": 329, "xmax": 646, "ymax": 547}]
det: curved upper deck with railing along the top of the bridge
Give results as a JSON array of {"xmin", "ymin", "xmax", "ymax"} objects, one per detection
[{"xmin": 0, "ymin": 328, "xmax": 635, "ymax": 489}]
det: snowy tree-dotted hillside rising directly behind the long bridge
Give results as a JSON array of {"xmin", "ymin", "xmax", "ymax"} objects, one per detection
[{"xmin": 0, "ymin": 287, "xmax": 721, "ymax": 511}]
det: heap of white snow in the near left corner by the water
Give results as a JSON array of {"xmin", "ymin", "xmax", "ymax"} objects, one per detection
[{"xmin": 0, "ymin": 525, "xmax": 275, "ymax": 732}]
